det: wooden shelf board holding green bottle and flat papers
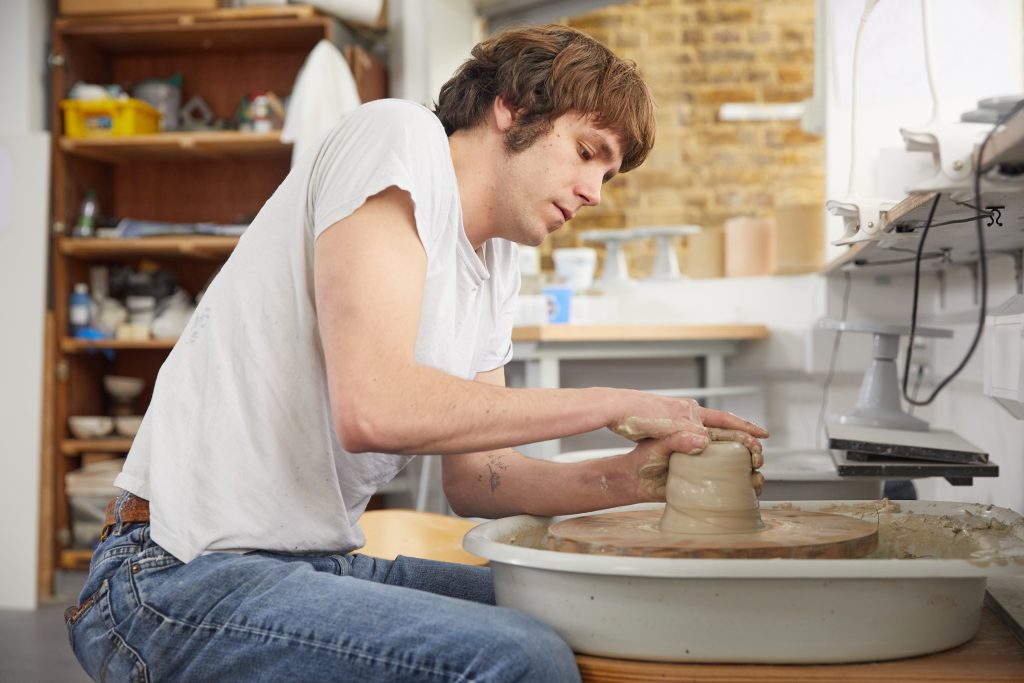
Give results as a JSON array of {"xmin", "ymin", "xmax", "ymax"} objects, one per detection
[{"xmin": 57, "ymin": 234, "xmax": 239, "ymax": 261}]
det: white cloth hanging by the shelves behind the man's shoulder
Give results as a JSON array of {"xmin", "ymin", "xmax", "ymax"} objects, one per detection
[{"xmin": 281, "ymin": 40, "xmax": 361, "ymax": 166}]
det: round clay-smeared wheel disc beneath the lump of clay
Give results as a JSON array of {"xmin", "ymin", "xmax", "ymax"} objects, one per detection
[{"xmin": 546, "ymin": 508, "xmax": 878, "ymax": 559}]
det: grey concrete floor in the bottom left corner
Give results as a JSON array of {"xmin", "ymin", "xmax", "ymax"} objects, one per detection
[{"xmin": 0, "ymin": 572, "xmax": 89, "ymax": 683}]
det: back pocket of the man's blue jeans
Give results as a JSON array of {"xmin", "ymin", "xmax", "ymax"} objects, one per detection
[{"xmin": 67, "ymin": 581, "xmax": 150, "ymax": 683}]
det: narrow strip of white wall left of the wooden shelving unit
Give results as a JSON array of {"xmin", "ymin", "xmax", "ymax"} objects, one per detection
[{"xmin": 0, "ymin": 0, "xmax": 49, "ymax": 609}]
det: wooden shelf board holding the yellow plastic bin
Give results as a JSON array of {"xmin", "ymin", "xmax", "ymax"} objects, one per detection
[{"xmin": 60, "ymin": 130, "xmax": 292, "ymax": 164}]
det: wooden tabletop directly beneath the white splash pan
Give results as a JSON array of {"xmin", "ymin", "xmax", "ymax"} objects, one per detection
[{"xmin": 577, "ymin": 607, "xmax": 1024, "ymax": 683}]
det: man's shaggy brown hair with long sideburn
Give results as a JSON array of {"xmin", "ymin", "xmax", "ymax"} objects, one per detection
[{"xmin": 434, "ymin": 25, "xmax": 654, "ymax": 173}]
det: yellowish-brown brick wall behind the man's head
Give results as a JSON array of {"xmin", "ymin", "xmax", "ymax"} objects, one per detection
[{"xmin": 543, "ymin": 0, "xmax": 824, "ymax": 276}]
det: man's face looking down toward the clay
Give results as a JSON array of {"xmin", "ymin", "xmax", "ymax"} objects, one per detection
[{"xmin": 496, "ymin": 112, "xmax": 623, "ymax": 246}]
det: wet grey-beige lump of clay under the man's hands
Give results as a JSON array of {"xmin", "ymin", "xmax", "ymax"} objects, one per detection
[{"xmin": 660, "ymin": 441, "xmax": 764, "ymax": 533}]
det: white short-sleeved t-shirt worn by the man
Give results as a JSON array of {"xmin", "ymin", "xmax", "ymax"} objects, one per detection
[{"xmin": 115, "ymin": 99, "xmax": 519, "ymax": 561}]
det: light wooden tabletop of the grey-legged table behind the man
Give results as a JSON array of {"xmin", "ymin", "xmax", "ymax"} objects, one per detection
[{"xmin": 512, "ymin": 325, "xmax": 768, "ymax": 342}]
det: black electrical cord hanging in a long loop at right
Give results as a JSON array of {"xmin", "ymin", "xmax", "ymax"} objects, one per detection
[{"xmin": 903, "ymin": 100, "xmax": 1024, "ymax": 405}]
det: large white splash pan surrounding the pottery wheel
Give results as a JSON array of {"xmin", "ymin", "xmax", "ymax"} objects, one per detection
[{"xmin": 463, "ymin": 501, "xmax": 1024, "ymax": 664}]
